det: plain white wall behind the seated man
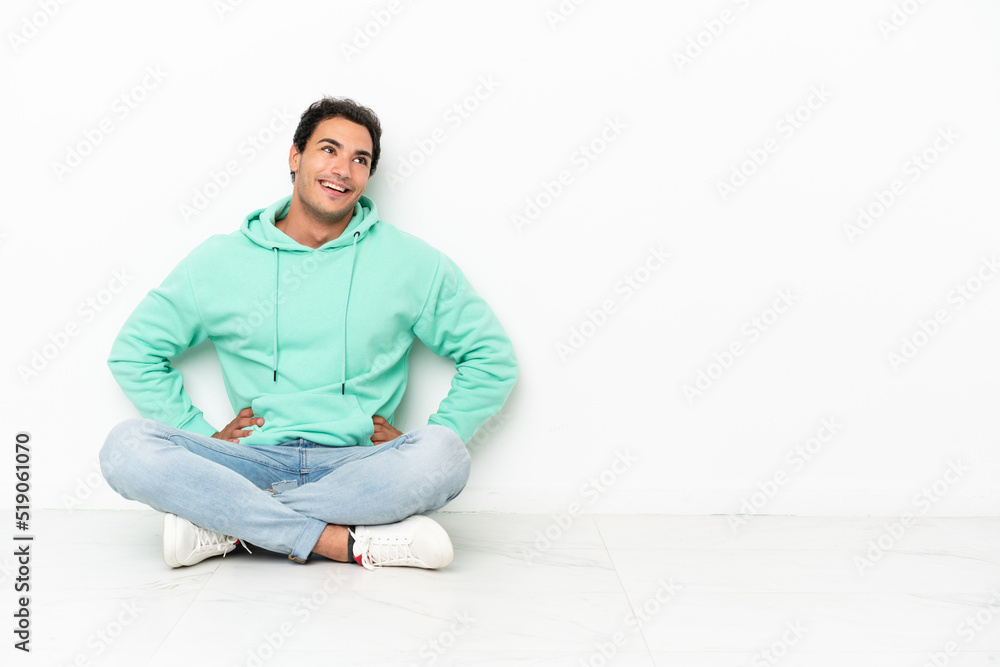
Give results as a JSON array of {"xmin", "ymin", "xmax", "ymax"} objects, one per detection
[{"xmin": 0, "ymin": 0, "xmax": 1000, "ymax": 515}]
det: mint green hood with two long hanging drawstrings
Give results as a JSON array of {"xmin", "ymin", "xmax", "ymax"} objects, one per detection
[{"xmin": 241, "ymin": 195, "xmax": 378, "ymax": 386}]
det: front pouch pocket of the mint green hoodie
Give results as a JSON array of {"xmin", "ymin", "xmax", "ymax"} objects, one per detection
[{"xmin": 244, "ymin": 385, "xmax": 375, "ymax": 447}]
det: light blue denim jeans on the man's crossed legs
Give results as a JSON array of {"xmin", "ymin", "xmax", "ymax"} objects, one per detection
[{"xmin": 100, "ymin": 419, "xmax": 470, "ymax": 562}]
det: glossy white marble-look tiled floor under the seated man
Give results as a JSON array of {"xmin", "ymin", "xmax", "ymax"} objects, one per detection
[{"xmin": 13, "ymin": 511, "xmax": 1000, "ymax": 667}]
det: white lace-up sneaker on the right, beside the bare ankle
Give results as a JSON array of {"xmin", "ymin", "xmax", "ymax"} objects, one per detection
[{"xmin": 351, "ymin": 514, "xmax": 455, "ymax": 570}]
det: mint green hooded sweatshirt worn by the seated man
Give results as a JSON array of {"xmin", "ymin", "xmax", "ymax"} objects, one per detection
[{"xmin": 108, "ymin": 196, "xmax": 517, "ymax": 446}]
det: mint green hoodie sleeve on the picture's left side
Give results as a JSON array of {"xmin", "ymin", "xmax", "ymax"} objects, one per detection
[{"xmin": 108, "ymin": 259, "xmax": 216, "ymax": 436}]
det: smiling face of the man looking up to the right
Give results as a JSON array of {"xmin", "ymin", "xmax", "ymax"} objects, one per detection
[{"xmin": 288, "ymin": 118, "xmax": 372, "ymax": 225}]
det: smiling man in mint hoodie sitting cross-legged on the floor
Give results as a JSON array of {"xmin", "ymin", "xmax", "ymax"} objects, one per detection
[{"xmin": 101, "ymin": 98, "xmax": 516, "ymax": 569}]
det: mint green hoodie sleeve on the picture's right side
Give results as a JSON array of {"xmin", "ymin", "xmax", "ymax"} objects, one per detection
[{"xmin": 413, "ymin": 255, "xmax": 517, "ymax": 442}]
